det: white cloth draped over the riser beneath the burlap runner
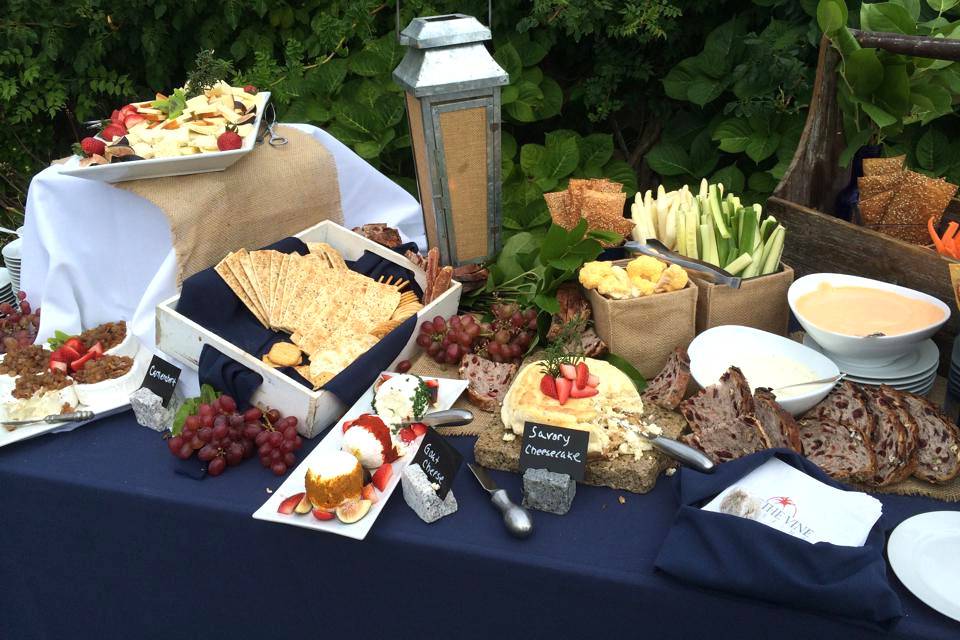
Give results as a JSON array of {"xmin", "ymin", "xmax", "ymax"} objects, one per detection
[{"xmin": 21, "ymin": 125, "xmax": 426, "ymax": 356}]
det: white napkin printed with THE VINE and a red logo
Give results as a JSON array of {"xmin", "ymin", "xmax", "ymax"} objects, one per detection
[{"xmin": 703, "ymin": 458, "xmax": 883, "ymax": 547}]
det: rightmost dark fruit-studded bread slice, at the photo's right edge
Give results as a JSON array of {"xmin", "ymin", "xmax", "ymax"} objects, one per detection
[{"xmin": 901, "ymin": 392, "xmax": 960, "ymax": 483}]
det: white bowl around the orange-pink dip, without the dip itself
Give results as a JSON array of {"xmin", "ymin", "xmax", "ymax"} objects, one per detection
[{"xmin": 787, "ymin": 273, "xmax": 950, "ymax": 367}]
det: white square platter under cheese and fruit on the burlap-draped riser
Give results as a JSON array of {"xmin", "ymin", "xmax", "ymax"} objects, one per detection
[{"xmin": 60, "ymin": 91, "xmax": 270, "ymax": 182}]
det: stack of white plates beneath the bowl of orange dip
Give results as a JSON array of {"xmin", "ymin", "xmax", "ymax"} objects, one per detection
[{"xmin": 803, "ymin": 335, "xmax": 940, "ymax": 396}]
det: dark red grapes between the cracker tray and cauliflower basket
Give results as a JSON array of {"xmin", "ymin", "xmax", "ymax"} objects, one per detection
[{"xmin": 417, "ymin": 303, "xmax": 537, "ymax": 364}]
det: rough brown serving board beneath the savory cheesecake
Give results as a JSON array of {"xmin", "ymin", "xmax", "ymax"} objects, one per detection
[{"xmin": 473, "ymin": 403, "xmax": 687, "ymax": 493}]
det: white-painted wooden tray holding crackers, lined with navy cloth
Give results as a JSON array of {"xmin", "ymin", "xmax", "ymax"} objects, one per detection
[{"xmin": 157, "ymin": 220, "xmax": 461, "ymax": 438}]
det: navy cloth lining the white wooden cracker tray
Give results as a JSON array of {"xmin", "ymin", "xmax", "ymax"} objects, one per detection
[{"xmin": 177, "ymin": 238, "xmax": 423, "ymax": 406}]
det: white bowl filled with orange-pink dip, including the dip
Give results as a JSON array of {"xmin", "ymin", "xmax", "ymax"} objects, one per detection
[{"xmin": 787, "ymin": 273, "xmax": 950, "ymax": 367}]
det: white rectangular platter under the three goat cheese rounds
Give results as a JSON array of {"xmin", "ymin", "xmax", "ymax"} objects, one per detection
[{"xmin": 253, "ymin": 372, "xmax": 467, "ymax": 540}]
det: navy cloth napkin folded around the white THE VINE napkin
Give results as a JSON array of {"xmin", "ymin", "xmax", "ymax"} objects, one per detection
[{"xmin": 654, "ymin": 449, "xmax": 903, "ymax": 630}]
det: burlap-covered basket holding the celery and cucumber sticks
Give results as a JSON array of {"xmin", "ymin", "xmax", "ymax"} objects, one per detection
[{"xmin": 687, "ymin": 265, "xmax": 793, "ymax": 336}]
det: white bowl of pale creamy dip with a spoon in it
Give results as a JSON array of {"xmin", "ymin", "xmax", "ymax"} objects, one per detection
[{"xmin": 687, "ymin": 325, "xmax": 840, "ymax": 416}]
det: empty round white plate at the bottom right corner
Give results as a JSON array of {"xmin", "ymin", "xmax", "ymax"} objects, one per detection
[{"xmin": 887, "ymin": 511, "xmax": 960, "ymax": 621}]
